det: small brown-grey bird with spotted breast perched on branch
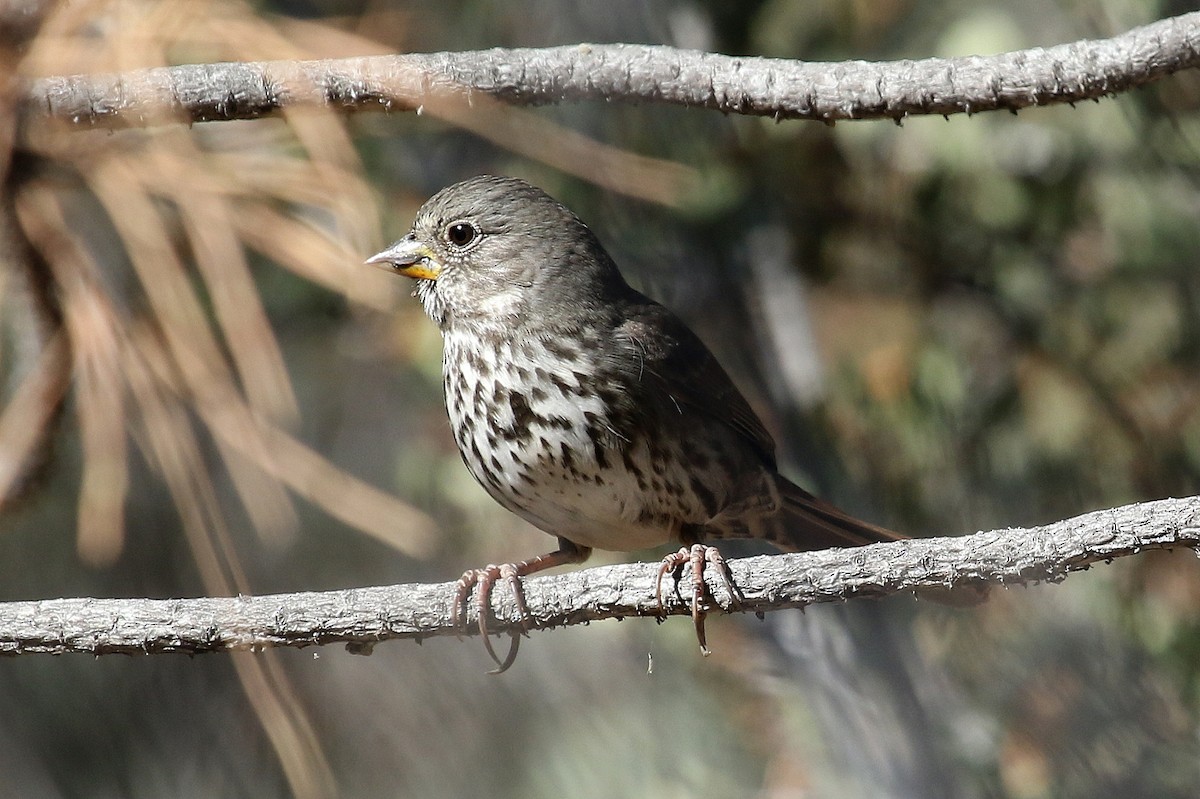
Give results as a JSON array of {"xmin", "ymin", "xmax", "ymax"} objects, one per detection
[{"xmin": 366, "ymin": 175, "xmax": 905, "ymax": 673}]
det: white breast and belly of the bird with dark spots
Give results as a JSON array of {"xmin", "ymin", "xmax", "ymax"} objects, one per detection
[{"xmin": 443, "ymin": 321, "xmax": 719, "ymax": 551}]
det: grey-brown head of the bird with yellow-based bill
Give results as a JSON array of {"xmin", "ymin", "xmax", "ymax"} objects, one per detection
[{"xmin": 366, "ymin": 175, "xmax": 624, "ymax": 330}]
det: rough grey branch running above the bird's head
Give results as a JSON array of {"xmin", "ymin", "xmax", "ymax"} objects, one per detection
[{"xmin": 25, "ymin": 12, "xmax": 1200, "ymax": 127}]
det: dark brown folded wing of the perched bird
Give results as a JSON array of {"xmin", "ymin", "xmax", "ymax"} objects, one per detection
[{"xmin": 614, "ymin": 300, "xmax": 775, "ymax": 468}]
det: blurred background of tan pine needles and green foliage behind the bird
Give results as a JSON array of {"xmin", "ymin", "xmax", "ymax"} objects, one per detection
[{"xmin": 0, "ymin": 0, "xmax": 1200, "ymax": 799}]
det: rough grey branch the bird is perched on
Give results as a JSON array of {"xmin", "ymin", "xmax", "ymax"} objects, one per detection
[{"xmin": 0, "ymin": 497, "xmax": 1200, "ymax": 655}]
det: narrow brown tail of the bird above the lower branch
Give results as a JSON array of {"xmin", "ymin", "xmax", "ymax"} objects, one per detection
[{"xmin": 767, "ymin": 475, "xmax": 908, "ymax": 552}]
